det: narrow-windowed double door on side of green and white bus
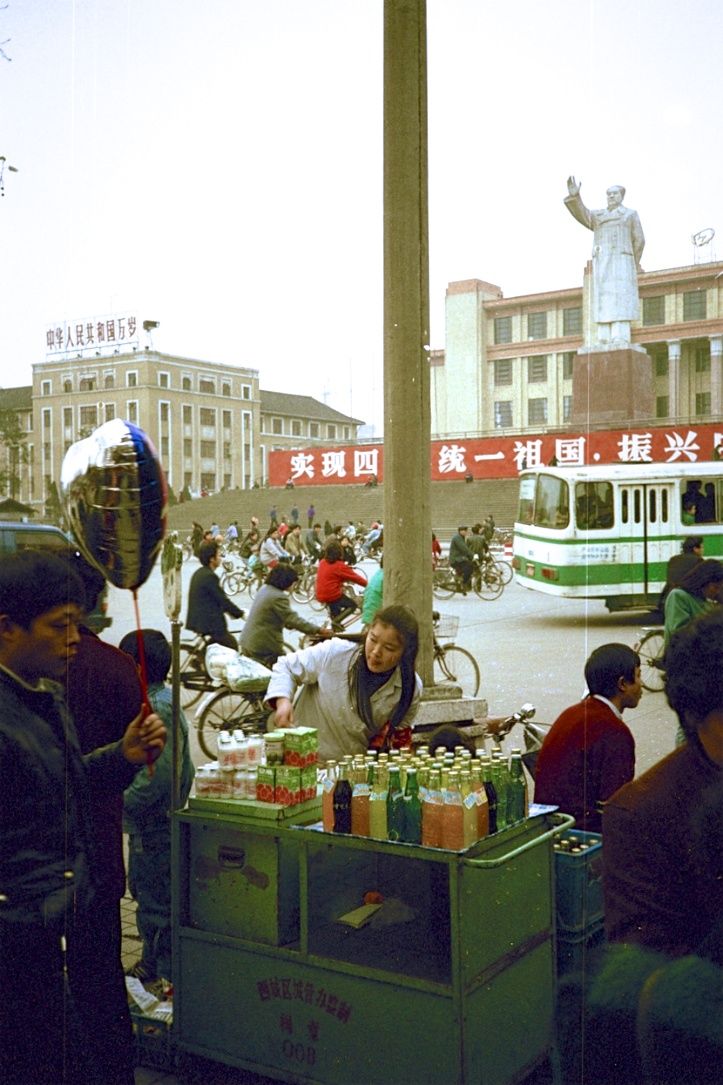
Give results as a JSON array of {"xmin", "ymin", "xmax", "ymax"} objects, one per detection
[{"xmin": 619, "ymin": 482, "xmax": 672, "ymax": 596}]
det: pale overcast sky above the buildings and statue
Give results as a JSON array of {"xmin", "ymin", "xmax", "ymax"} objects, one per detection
[{"xmin": 0, "ymin": 0, "xmax": 723, "ymax": 423}]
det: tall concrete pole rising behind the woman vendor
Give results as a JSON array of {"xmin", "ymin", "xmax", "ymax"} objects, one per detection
[{"xmin": 384, "ymin": 0, "xmax": 432, "ymax": 686}]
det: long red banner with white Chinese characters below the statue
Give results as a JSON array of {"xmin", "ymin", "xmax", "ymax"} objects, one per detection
[{"xmin": 269, "ymin": 423, "xmax": 723, "ymax": 486}]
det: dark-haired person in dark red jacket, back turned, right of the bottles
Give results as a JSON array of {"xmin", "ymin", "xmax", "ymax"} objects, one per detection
[{"xmin": 535, "ymin": 643, "xmax": 643, "ymax": 832}]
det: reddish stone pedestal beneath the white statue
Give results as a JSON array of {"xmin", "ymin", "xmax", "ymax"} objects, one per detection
[{"xmin": 570, "ymin": 348, "xmax": 656, "ymax": 425}]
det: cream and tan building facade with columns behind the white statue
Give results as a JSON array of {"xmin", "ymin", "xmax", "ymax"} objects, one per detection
[{"xmin": 430, "ymin": 263, "xmax": 723, "ymax": 437}]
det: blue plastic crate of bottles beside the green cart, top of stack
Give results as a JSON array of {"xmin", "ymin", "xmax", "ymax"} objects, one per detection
[{"xmin": 554, "ymin": 829, "xmax": 605, "ymax": 934}]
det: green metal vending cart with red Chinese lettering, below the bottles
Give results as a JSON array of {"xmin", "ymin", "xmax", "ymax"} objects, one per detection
[{"xmin": 174, "ymin": 800, "xmax": 572, "ymax": 1085}]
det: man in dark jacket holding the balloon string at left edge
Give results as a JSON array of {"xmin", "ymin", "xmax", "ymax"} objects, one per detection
[{"xmin": 0, "ymin": 550, "xmax": 165, "ymax": 1085}]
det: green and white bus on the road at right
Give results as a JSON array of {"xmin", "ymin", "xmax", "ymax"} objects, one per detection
[{"xmin": 512, "ymin": 462, "xmax": 723, "ymax": 611}]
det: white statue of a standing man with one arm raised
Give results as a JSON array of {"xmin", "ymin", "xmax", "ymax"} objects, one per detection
[{"xmin": 565, "ymin": 177, "xmax": 645, "ymax": 350}]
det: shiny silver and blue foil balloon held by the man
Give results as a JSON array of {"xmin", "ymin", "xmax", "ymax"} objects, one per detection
[{"xmin": 61, "ymin": 418, "xmax": 167, "ymax": 588}]
